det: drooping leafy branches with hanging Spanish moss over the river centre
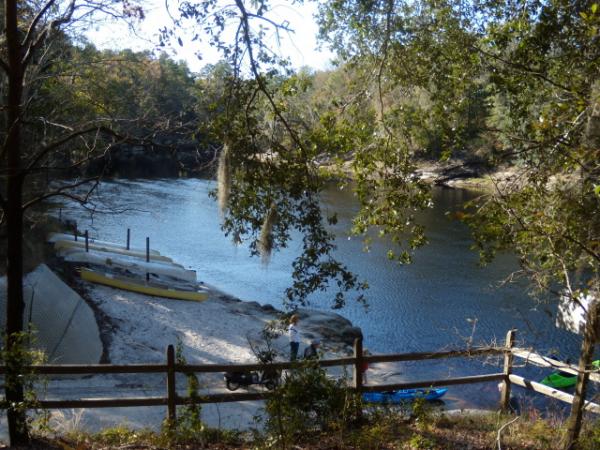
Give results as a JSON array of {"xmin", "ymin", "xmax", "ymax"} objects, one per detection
[{"xmin": 164, "ymin": 0, "xmax": 365, "ymax": 307}]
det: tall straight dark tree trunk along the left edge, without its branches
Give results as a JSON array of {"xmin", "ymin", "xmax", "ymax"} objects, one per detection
[{"xmin": 4, "ymin": 0, "xmax": 29, "ymax": 446}]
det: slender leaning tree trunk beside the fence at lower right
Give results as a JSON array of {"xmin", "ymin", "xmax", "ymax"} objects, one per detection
[{"xmin": 565, "ymin": 301, "xmax": 600, "ymax": 450}]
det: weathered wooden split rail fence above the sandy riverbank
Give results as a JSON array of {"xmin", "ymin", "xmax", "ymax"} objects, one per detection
[{"xmin": 0, "ymin": 330, "xmax": 600, "ymax": 423}]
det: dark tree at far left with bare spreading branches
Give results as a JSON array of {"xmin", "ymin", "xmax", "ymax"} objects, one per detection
[{"xmin": 0, "ymin": 0, "xmax": 142, "ymax": 445}]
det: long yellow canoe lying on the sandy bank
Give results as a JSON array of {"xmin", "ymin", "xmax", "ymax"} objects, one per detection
[{"xmin": 81, "ymin": 268, "xmax": 208, "ymax": 301}]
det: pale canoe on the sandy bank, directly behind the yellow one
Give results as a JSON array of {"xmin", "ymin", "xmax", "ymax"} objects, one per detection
[{"xmin": 58, "ymin": 248, "xmax": 196, "ymax": 282}]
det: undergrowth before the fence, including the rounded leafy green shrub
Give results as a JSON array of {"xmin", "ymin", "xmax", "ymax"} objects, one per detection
[{"xmin": 16, "ymin": 356, "xmax": 600, "ymax": 450}]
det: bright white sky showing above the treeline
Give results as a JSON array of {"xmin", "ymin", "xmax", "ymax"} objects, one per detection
[{"xmin": 87, "ymin": 0, "xmax": 333, "ymax": 72}]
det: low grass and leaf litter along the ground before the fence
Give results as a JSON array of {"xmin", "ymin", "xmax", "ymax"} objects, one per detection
[{"xmin": 5, "ymin": 409, "xmax": 600, "ymax": 450}]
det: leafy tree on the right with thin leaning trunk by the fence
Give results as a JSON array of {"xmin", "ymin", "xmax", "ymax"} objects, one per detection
[{"xmin": 321, "ymin": 0, "xmax": 600, "ymax": 448}]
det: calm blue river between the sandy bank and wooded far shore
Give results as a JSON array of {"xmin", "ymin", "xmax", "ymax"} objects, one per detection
[{"xmin": 56, "ymin": 179, "xmax": 592, "ymax": 407}]
